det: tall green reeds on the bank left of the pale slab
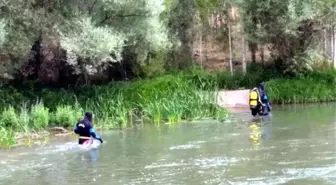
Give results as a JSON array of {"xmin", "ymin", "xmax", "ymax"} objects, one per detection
[{"xmin": 0, "ymin": 74, "xmax": 227, "ymax": 147}]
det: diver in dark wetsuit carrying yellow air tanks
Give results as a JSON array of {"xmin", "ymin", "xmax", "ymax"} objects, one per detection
[{"xmin": 250, "ymin": 82, "xmax": 272, "ymax": 116}]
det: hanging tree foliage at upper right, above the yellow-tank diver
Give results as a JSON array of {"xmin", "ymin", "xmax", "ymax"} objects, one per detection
[{"xmin": 240, "ymin": 0, "xmax": 336, "ymax": 73}]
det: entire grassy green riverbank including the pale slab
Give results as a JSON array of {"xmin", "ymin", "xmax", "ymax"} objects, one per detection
[{"xmin": 0, "ymin": 67, "xmax": 336, "ymax": 147}]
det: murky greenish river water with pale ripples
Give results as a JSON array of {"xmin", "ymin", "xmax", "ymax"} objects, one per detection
[{"xmin": 0, "ymin": 104, "xmax": 336, "ymax": 185}]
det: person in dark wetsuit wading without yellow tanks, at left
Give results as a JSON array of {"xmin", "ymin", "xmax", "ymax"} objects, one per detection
[{"xmin": 74, "ymin": 112, "xmax": 103, "ymax": 145}]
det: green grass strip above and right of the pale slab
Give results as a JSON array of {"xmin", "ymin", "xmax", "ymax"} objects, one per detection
[{"xmin": 189, "ymin": 66, "xmax": 336, "ymax": 104}]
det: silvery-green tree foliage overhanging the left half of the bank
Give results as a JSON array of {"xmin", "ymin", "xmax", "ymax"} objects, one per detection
[{"xmin": 0, "ymin": 0, "xmax": 170, "ymax": 82}]
